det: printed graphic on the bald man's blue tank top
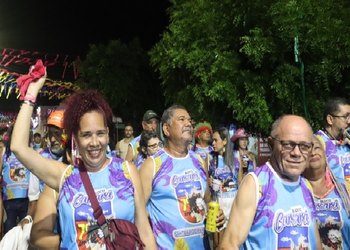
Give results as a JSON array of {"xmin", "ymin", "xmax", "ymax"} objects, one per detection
[{"xmin": 273, "ymin": 207, "xmax": 311, "ymax": 250}]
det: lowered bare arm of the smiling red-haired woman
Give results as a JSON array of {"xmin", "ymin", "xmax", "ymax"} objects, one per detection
[{"xmin": 129, "ymin": 163, "xmax": 157, "ymax": 250}]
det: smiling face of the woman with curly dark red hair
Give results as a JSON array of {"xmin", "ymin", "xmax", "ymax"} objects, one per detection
[{"xmin": 77, "ymin": 111, "xmax": 109, "ymax": 171}]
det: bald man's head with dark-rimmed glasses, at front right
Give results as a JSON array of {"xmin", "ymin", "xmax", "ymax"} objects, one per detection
[{"xmin": 270, "ymin": 115, "xmax": 312, "ymax": 181}]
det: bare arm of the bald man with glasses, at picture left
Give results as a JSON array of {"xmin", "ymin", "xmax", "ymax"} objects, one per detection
[{"xmin": 220, "ymin": 174, "xmax": 257, "ymax": 250}]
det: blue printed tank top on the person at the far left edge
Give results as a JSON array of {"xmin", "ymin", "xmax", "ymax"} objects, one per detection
[{"xmin": 2, "ymin": 152, "xmax": 30, "ymax": 201}]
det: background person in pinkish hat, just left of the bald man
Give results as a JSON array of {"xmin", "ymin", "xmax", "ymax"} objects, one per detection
[{"xmin": 231, "ymin": 128, "xmax": 256, "ymax": 184}]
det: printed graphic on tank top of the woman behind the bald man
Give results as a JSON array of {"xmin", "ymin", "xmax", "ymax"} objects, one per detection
[{"xmin": 315, "ymin": 198, "xmax": 343, "ymax": 249}]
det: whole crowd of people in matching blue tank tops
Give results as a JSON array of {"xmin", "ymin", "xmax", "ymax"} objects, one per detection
[{"xmin": 0, "ymin": 63, "xmax": 350, "ymax": 249}]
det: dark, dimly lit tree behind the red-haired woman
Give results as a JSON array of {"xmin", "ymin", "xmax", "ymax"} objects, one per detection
[{"xmin": 79, "ymin": 39, "xmax": 164, "ymax": 127}]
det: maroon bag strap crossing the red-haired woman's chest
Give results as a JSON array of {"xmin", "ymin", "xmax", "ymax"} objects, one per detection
[{"xmin": 79, "ymin": 163, "xmax": 106, "ymax": 227}]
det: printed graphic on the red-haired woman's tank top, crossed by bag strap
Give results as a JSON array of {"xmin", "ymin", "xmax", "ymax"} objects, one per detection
[{"xmin": 72, "ymin": 189, "xmax": 114, "ymax": 249}]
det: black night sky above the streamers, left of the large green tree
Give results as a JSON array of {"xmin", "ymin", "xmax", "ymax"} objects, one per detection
[{"xmin": 0, "ymin": 0, "xmax": 170, "ymax": 55}]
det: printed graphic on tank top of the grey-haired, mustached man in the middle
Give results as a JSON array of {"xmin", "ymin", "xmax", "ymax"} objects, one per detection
[{"xmin": 171, "ymin": 170, "xmax": 206, "ymax": 223}]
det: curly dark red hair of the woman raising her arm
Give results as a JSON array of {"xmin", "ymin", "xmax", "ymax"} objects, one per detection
[{"xmin": 63, "ymin": 89, "xmax": 113, "ymax": 137}]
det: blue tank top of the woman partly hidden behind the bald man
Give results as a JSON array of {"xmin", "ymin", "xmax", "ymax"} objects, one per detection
[{"xmin": 315, "ymin": 183, "xmax": 350, "ymax": 249}]
